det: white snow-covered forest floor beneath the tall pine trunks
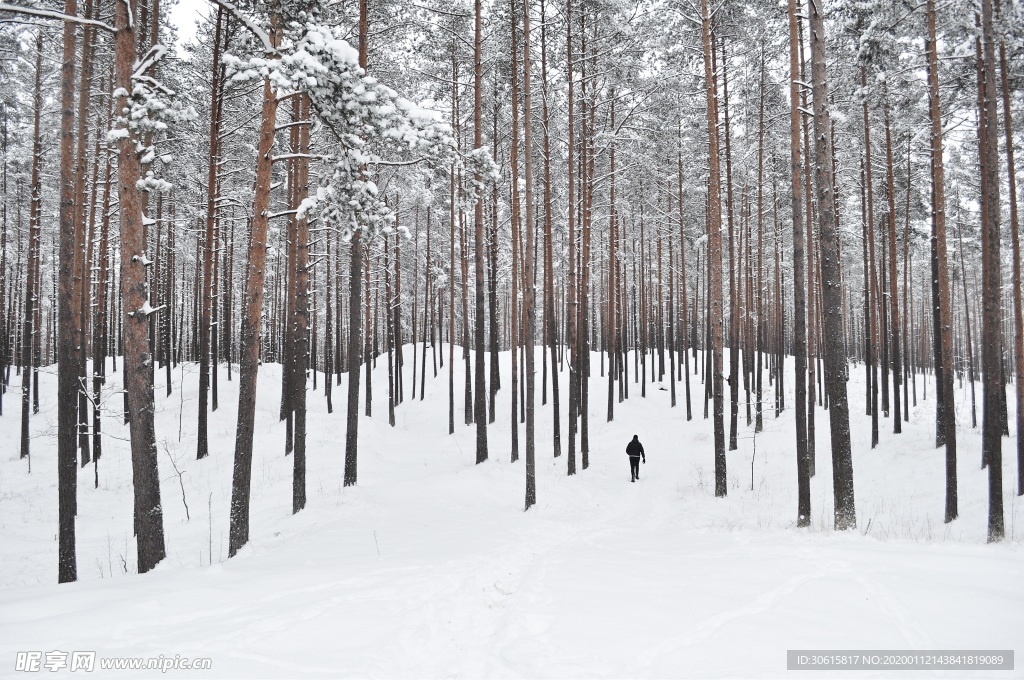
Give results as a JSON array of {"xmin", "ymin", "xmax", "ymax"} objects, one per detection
[{"xmin": 0, "ymin": 347, "xmax": 1024, "ymax": 678}]
